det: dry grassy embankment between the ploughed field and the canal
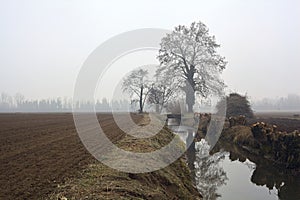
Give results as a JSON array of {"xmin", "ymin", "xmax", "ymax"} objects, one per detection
[{"xmin": 50, "ymin": 116, "xmax": 201, "ymax": 200}]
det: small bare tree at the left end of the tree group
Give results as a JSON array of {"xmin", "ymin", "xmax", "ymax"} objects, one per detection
[{"xmin": 122, "ymin": 69, "xmax": 152, "ymax": 113}]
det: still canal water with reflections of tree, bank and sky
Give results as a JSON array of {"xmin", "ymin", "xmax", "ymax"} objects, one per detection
[{"xmin": 172, "ymin": 130, "xmax": 300, "ymax": 200}]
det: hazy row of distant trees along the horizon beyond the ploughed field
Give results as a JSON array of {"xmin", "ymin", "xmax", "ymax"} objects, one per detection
[{"xmin": 0, "ymin": 93, "xmax": 137, "ymax": 112}]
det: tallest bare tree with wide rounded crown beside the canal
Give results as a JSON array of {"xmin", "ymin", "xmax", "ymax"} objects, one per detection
[{"xmin": 157, "ymin": 22, "xmax": 226, "ymax": 112}]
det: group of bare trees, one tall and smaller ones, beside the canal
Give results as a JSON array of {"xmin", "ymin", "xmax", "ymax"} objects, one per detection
[{"xmin": 122, "ymin": 22, "xmax": 226, "ymax": 112}]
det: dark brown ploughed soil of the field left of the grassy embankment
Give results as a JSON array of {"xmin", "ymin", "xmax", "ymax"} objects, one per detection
[{"xmin": 0, "ymin": 113, "xmax": 139, "ymax": 199}]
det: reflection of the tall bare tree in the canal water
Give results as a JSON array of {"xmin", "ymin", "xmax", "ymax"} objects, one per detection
[{"xmin": 195, "ymin": 139, "xmax": 228, "ymax": 200}]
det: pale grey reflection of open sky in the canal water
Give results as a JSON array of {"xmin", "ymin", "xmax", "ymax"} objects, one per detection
[{"xmin": 218, "ymin": 155, "xmax": 278, "ymax": 200}]
